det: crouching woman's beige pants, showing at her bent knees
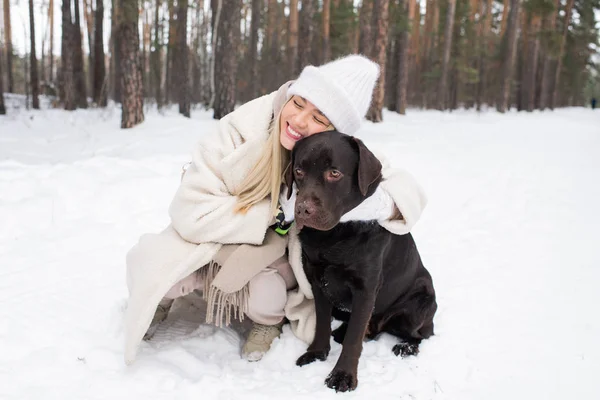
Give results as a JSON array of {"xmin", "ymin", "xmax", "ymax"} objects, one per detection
[{"xmin": 165, "ymin": 256, "xmax": 298, "ymax": 325}]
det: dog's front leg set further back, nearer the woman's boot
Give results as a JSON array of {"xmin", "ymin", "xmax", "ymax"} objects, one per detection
[{"xmin": 296, "ymin": 284, "xmax": 332, "ymax": 366}]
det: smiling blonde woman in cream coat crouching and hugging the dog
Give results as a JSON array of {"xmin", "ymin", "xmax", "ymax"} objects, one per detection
[{"xmin": 125, "ymin": 55, "xmax": 426, "ymax": 363}]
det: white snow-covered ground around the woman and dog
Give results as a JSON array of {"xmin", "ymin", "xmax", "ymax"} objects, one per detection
[{"xmin": 0, "ymin": 104, "xmax": 600, "ymax": 400}]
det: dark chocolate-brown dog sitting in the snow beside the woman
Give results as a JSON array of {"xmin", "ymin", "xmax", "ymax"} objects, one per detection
[{"xmin": 285, "ymin": 131, "xmax": 437, "ymax": 391}]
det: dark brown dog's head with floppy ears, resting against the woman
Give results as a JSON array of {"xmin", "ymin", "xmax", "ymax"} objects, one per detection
[{"xmin": 285, "ymin": 131, "xmax": 381, "ymax": 231}]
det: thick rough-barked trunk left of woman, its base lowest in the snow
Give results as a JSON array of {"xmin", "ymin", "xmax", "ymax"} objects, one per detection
[{"xmin": 118, "ymin": 0, "xmax": 144, "ymax": 128}]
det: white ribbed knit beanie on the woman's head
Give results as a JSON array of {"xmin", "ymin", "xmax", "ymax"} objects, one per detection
[{"xmin": 287, "ymin": 54, "xmax": 379, "ymax": 135}]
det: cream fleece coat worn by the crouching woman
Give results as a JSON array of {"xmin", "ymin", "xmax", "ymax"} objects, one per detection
[{"xmin": 124, "ymin": 84, "xmax": 427, "ymax": 364}]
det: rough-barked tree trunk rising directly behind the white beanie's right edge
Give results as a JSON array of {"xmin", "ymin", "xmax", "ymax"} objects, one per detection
[{"xmin": 367, "ymin": 0, "xmax": 390, "ymax": 122}]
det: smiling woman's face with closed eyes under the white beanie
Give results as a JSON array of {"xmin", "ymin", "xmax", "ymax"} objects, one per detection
[{"xmin": 279, "ymin": 96, "xmax": 333, "ymax": 150}]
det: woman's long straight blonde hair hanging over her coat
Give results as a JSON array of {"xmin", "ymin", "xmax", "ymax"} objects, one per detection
[{"xmin": 235, "ymin": 107, "xmax": 290, "ymax": 215}]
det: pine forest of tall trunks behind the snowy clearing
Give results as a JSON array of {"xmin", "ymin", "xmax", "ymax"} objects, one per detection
[{"xmin": 0, "ymin": 0, "xmax": 600, "ymax": 128}]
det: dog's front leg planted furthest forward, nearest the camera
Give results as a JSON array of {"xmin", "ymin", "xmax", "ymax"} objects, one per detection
[{"xmin": 325, "ymin": 289, "xmax": 376, "ymax": 392}]
